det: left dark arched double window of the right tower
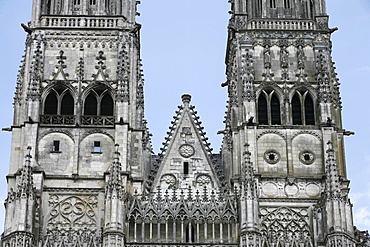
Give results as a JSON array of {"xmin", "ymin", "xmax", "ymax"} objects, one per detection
[{"xmin": 258, "ymin": 90, "xmax": 281, "ymax": 125}]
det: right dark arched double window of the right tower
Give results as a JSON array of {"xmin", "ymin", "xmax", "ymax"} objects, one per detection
[{"xmin": 291, "ymin": 91, "xmax": 316, "ymax": 125}]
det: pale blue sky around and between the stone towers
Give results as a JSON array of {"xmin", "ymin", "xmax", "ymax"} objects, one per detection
[{"xmin": 0, "ymin": 0, "xmax": 370, "ymax": 232}]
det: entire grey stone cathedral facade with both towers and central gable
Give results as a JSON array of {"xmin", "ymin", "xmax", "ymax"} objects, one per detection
[{"xmin": 1, "ymin": 0, "xmax": 370, "ymax": 247}]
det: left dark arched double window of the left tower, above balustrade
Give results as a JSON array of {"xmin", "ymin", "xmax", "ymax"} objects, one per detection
[{"xmin": 44, "ymin": 88, "xmax": 74, "ymax": 115}]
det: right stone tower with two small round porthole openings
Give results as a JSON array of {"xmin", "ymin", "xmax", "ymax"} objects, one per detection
[{"xmin": 222, "ymin": 0, "xmax": 366, "ymax": 246}]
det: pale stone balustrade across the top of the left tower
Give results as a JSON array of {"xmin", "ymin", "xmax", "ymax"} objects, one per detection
[{"xmin": 41, "ymin": 16, "xmax": 124, "ymax": 29}]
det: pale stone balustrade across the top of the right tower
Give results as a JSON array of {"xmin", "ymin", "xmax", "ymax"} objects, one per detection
[{"xmin": 248, "ymin": 19, "xmax": 315, "ymax": 30}]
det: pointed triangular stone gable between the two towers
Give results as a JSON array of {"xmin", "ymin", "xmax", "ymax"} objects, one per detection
[{"xmin": 151, "ymin": 94, "xmax": 222, "ymax": 192}]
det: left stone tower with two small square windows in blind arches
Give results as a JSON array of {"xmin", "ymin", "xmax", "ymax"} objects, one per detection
[{"xmin": 2, "ymin": 0, "xmax": 151, "ymax": 246}]
